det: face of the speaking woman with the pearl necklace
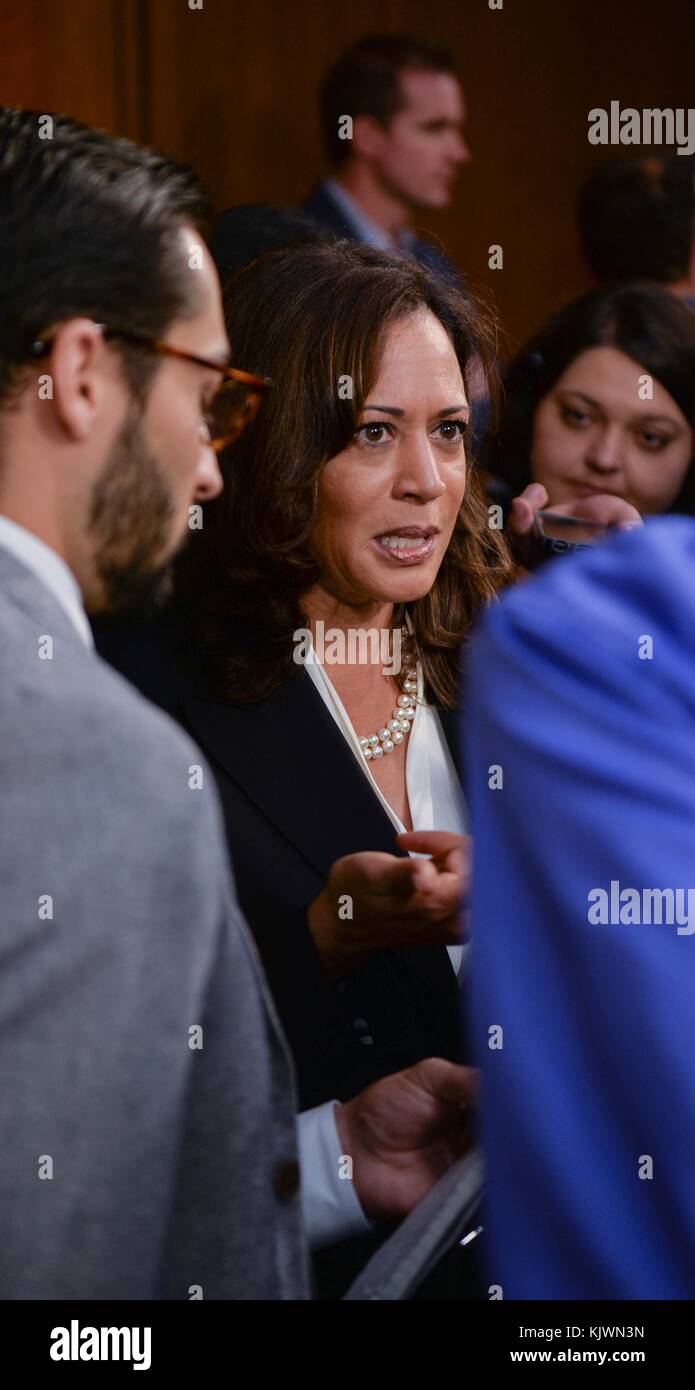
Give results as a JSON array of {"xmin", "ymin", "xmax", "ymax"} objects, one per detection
[{"xmin": 311, "ymin": 310, "xmax": 470, "ymax": 605}]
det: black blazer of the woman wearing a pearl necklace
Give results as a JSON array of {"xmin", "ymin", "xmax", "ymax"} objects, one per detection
[{"xmin": 96, "ymin": 620, "xmax": 461, "ymax": 1108}]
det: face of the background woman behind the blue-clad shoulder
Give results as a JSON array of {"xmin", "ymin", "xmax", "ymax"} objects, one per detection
[{"xmin": 531, "ymin": 348, "xmax": 692, "ymax": 514}]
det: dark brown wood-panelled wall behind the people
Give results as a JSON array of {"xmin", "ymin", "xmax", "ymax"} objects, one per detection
[{"xmin": 0, "ymin": 0, "xmax": 695, "ymax": 342}]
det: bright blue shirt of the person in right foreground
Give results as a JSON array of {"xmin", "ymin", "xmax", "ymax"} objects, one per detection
[{"xmin": 466, "ymin": 517, "xmax": 695, "ymax": 1298}]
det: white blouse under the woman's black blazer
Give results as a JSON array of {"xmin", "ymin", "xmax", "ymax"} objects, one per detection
[{"xmin": 306, "ymin": 644, "xmax": 468, "ymax": 973}]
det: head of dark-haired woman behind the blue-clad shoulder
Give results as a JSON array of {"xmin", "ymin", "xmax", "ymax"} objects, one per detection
[{"xmin": 487, "ymin": 282, "xmax": 695, "ymax": 516}]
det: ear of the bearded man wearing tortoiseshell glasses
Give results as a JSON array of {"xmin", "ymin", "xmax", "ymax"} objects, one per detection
[{"xmin": 39, "ymin": 318, "xmax": 115, "ymax": 443}]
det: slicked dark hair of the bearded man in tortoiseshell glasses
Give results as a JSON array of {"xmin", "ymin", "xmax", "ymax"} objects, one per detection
[{"xmin": 0, "ymin": 107, "xmax": 207, "ymax": 404}]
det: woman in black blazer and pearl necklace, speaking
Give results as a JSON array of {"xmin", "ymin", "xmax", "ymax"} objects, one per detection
[{"xmin": 101, "ymin": 240, "xmax": 514, "ymax": 1106}]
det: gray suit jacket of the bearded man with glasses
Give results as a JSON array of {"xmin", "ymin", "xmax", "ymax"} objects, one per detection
[{"xmin": 0, "ymin": 549, "xmax": 309, "ymax": 1300}]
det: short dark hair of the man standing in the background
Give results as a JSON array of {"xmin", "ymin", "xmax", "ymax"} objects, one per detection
[{"xmin": 318, "ymin": 35, "xmax": 457, "ymax": 164}]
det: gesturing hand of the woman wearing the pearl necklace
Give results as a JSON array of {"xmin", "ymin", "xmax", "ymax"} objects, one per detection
[{"xmin": 307, "ymin": 830, "xmax": 471, "ymax": 980}]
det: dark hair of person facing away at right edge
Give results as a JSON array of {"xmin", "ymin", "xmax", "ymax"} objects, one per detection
[{"xmin": 577, "ymin": 154, "xmax": 695, "ymax": 285}]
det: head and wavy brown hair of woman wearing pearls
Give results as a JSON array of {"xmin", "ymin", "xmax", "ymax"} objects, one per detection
[{"xmin": 193, "ymin": 242, "xmax": 512, "ymax": 706}]
